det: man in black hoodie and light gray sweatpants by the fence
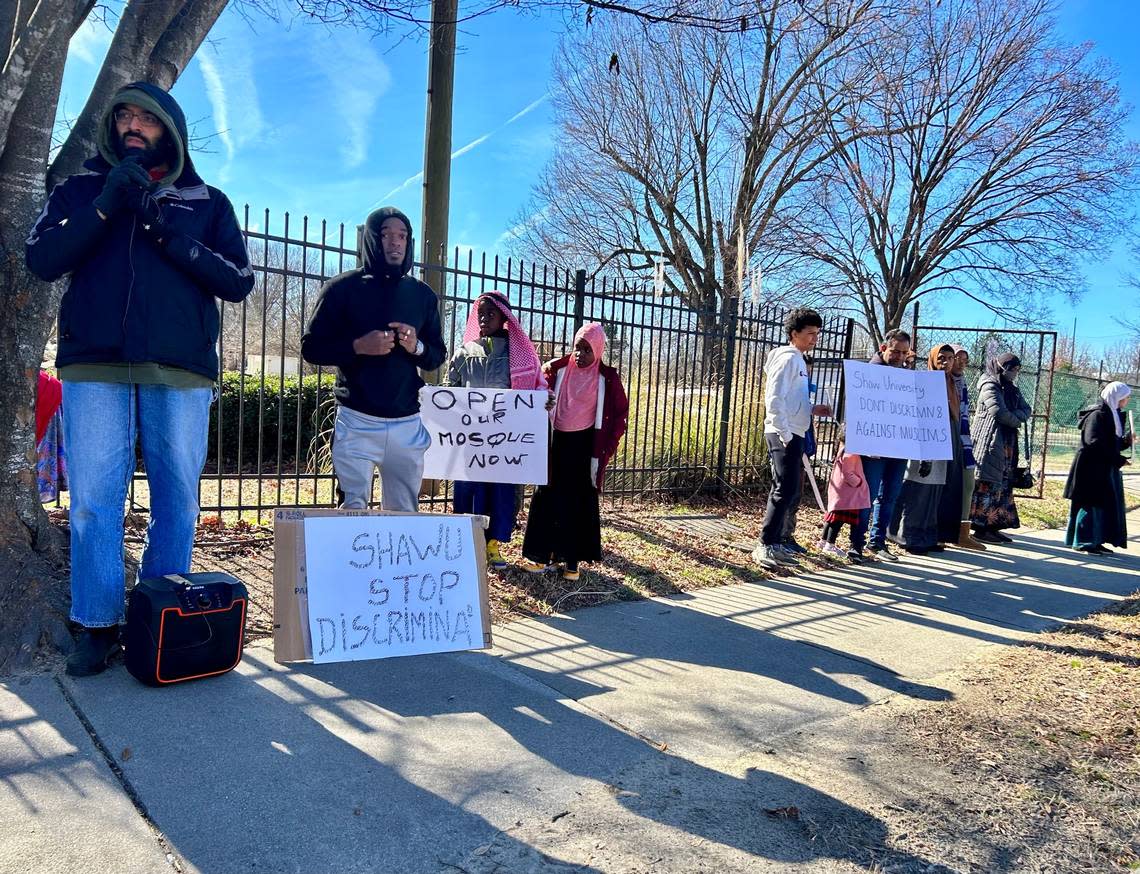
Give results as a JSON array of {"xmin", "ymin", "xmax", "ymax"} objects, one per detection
[{"xmin": 301, "ymin": 206, "xmax": 447, "ymax": 513}]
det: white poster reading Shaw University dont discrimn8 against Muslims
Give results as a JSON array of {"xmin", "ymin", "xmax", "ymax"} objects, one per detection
[{"xmin": 844, "ymin": 361, "xmax": 954, "ymax": 461}]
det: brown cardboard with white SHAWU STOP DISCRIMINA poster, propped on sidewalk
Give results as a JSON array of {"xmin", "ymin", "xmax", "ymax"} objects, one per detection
[{"xmin": 274, "ymin": 508, "xmax": 491, "ymax": 663}]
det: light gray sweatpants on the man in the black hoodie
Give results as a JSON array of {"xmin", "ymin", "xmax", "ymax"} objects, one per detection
[{"xmin": 333, "ymin": 407, "xmax": 431, "ymax": 513}]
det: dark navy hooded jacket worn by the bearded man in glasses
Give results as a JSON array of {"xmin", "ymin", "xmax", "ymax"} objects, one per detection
[{"xmin": 26, "ymin": 82, "xmax": 253, "ymax": 379}]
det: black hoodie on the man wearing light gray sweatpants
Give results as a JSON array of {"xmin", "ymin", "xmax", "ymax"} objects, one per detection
[{"xmin": 301, "ymin": 206, "xmax": 447, "ymax": 418}]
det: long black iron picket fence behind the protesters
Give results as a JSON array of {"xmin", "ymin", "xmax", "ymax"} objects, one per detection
[{"xmin": 113, "ymin": 209, "xmax": 853, "ymax": 520}]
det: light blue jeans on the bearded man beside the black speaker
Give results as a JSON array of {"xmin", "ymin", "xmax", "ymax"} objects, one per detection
[{"xmin": 63, "ymin": 382, "xmax": 213, "ymax": 628}]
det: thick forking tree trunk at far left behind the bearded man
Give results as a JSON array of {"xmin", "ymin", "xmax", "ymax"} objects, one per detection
[{"xmin": 0, "ymin": 0, "xmax": 227, "ymax": 672}]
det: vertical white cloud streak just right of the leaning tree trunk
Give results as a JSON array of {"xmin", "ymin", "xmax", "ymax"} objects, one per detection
[{"xmin": 197, "ymin": 31, "xmax": 264, "ymax": 183}]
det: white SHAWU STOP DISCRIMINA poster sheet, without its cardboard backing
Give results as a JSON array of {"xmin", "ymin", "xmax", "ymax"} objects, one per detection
[{"xmin": 304, "ymin": 514, "xmax": 483, "ymax": 664}]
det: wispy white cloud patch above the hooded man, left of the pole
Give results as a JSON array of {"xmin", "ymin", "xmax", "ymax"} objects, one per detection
[{"xmin": 311, "ymin": 31, "xmax": 392, "ymax": 168}]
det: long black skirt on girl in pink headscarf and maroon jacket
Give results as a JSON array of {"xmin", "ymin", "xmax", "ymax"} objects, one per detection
[{"xmin": 522, "ymin": 428, "xmax": 602, "ymax": 565}]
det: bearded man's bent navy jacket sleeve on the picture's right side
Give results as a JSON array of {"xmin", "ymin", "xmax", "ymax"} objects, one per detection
[{"xmin": 163, "ymin": 189, "xmax": 253, "ymax": 303}]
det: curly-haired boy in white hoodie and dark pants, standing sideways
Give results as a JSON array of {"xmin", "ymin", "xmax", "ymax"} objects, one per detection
[{"xmin": 752, "ymin": 308, "xmax": 831, "ymax": 569}]
